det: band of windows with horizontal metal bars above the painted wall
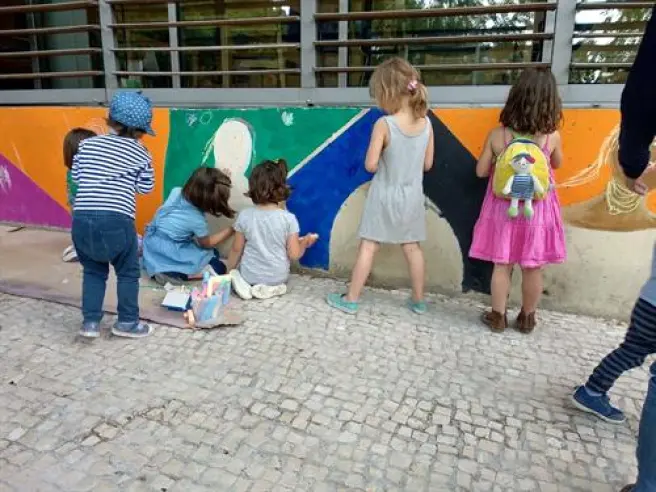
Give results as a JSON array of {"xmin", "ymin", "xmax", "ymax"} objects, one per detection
[{"xmin": 0, "ymin": 0, "xmax": 654, "ymax": 106}]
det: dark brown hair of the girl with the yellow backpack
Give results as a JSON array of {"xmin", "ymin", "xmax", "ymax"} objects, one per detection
[{"xmin": 499, "ymin": 69, "xmax": 563, "ymax": 135}]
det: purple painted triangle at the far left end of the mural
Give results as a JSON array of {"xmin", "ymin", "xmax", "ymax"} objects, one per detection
[{"xmin": 0, "ymin": 154, "xmax": 71, "ymax": 229}]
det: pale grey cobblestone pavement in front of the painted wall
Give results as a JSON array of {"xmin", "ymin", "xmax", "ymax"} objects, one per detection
[{"xmin": 0, "ymin": 278, "xmax": 647, "ymax": 492}]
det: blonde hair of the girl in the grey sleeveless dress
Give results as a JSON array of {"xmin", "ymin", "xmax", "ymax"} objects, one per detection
[{"xmin": 369, "ymin": 57, "xmax": 428, "ymax": 118}]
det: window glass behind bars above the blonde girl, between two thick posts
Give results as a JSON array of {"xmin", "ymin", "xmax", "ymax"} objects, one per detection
[{"xmin": 317, "ymin": 0, "xmax": 553, "ymax": 87}]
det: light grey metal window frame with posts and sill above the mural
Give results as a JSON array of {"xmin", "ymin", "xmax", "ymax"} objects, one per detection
[{"xmin": 0, "ymin": 0, "xmax": 654, "ymax": 107}]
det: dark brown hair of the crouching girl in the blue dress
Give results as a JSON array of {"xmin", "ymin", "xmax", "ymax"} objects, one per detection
[{"xmin": 182, "ymin": 167, "xmax": 235, "ymax": 219}]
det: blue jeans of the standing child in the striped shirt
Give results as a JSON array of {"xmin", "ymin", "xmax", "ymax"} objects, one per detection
[{"xmin": 72, "ymin": 211, "xmax": 141, "ymax": 323}]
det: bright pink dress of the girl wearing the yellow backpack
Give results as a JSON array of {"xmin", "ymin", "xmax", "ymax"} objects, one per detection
[{"xmin": 469, "ymin": 133, "xmax": 567, "ymax": 268}]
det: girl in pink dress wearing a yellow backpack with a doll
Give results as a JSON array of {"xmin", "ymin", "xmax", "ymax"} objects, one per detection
[{"xmin": 469, "ymin": 69, "xmax": 566, "ymax": 333}]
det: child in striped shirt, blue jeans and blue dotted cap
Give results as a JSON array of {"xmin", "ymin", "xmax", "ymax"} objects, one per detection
[{"xmin": 71, "ymin": 91, "xmax": 154, "ymax": 338}]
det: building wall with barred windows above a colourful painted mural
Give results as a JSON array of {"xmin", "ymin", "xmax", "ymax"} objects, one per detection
[{"xmin": 0, "ymin": 0, "xmax": 656, "ymax": 315}]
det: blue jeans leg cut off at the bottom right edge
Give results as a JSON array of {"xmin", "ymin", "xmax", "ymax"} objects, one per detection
[{"xmin": 633, "ymin": 363, "xmax": 656, "ymax": 492}]
